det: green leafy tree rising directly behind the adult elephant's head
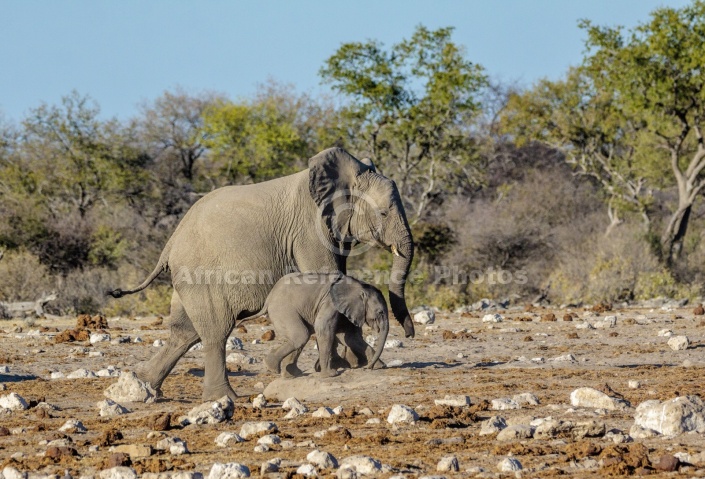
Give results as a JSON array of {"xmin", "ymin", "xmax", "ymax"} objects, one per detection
[{"xmin": 320, "ymin": 26, "xmax": 487, "ymax": 223}]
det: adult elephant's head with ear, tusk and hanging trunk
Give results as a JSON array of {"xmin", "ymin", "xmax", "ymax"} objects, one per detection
[{"xmin": 309, "ymin": 148, "xmax": 414, "ymax": 337}]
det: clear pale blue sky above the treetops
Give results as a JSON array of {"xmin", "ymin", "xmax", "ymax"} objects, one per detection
[{"xmin": 0, "ymin": 0, "xmax": 688, "ymax": 121}]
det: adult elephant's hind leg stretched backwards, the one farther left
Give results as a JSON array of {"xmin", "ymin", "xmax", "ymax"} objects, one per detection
[{"xmin": 136, "ymin": 291, "xmax": 201, "ymax": 395}]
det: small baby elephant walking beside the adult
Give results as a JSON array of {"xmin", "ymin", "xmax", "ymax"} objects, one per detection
[{"xmin": 239, "ymin": 272, "xmax": 389, "ymax": 377}]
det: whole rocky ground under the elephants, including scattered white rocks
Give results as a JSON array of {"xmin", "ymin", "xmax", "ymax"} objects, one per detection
[{"xmin": 0, "ymin": 306, "xmax": 705, "ymax": 479}]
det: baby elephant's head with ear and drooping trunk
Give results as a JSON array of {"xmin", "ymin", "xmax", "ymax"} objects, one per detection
[{"xmin": 330, "ymin": 276, "xmax": 389, "ymax": 369}]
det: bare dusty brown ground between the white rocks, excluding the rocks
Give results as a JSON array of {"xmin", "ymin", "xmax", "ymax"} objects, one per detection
[{"xmin": 0, "ymin": 307, "xmax": 705, "ymax": 477}]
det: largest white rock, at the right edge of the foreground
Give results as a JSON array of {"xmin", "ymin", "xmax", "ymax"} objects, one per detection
[{"xmin": 630, "ymin": 396, "xmax": 705, "ymax": 437}]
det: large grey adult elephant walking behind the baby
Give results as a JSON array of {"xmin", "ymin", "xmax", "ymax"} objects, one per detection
[{"xmin": 108, "ymin": 148, "xmax": 414, "ymax": 400}]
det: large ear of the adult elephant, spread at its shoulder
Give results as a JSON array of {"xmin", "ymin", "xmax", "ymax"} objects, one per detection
[{"xmin": 308, "ymin": 148, "xmax": 375, "ymax": 241}]
